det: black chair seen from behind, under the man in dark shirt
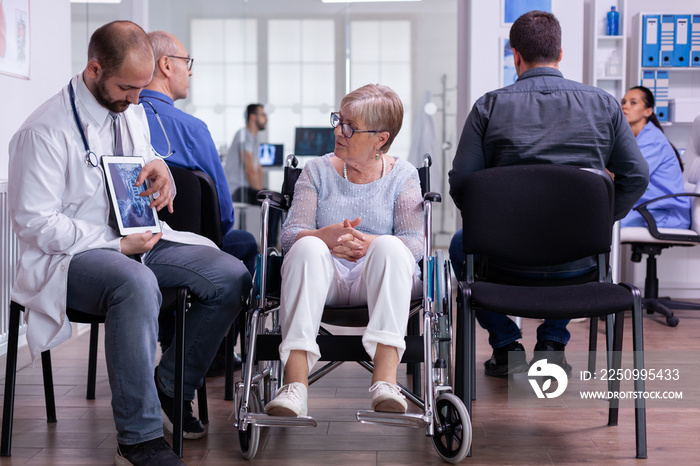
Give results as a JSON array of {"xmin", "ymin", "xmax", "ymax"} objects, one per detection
[{"xmin": 456, "ymin": 165, "xmax": 647, "ymax": 458}]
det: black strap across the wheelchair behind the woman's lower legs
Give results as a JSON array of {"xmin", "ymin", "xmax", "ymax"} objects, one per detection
[{"xmin": 255, "ymin": 334, "xmax": 423, "ymax": 362}]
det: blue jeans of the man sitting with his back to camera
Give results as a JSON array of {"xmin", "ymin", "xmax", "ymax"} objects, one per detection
[{"xmin": 450, "ymin": 230, "xmax": 595, "ymax": 348}]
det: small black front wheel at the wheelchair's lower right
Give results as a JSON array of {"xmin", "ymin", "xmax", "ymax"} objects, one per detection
[{"xmin": 433, "ymin": 393, "xmax": 472, "ymax": 463}]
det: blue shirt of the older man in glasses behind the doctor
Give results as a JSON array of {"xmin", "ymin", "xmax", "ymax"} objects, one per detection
[{"xmin": 139, "ymin": 89, "xmax": 234, "ymax": 236}]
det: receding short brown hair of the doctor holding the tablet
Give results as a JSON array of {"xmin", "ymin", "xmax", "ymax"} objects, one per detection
[{"xmin": 88, "ymin": 21, "xmax": 153, "ymax": 77}]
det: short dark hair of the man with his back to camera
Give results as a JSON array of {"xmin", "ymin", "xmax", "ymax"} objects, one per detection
[{"xmin": 510, "ymin": 10, "xmax": 561, "ymax": 65}]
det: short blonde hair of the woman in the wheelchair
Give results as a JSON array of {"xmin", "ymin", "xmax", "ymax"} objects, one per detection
[{"xmin": 340, "ymin": 84, "xmax": 403, "ymax": 153}]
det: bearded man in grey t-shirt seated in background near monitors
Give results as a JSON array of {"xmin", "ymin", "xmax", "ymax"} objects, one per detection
[{"xmin": 224, "ymin": 104, "xmax": 281, "ymax": 246}]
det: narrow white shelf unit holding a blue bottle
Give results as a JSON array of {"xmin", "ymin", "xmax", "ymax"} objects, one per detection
[{"xmin": 588, "ymin": 0, "xmax": 628, "ymax": 101}]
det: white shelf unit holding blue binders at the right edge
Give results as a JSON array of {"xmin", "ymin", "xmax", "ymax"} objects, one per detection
[{"xmin": 629, "ymin": 12, "xmax": 700, "ymax": 125}]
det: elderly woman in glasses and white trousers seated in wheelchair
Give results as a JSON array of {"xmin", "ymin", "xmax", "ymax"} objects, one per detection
[{"xmin": 265, "ymin": 85, "xmax": 423, "ymax": 416}]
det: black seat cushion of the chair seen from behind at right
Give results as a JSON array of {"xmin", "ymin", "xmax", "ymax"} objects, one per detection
[{"xmin": 469, "ymin": 282, "xmax": 634, "ymax": 319}]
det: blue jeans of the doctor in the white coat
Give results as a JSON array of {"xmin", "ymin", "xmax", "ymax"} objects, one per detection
[{"xmin": 67, "ymin": 240, "xmax": 251, "ymax": 445}]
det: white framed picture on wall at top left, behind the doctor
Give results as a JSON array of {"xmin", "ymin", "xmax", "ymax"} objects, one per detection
[{"xmin": 0, "ymin": 0, "xmax": 31, "ymax": 79}]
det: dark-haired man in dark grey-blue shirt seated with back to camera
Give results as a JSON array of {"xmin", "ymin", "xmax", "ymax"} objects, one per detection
[{"xmin": 449, "ymin": 11, "xmax": 649, "ymax": 376}]
